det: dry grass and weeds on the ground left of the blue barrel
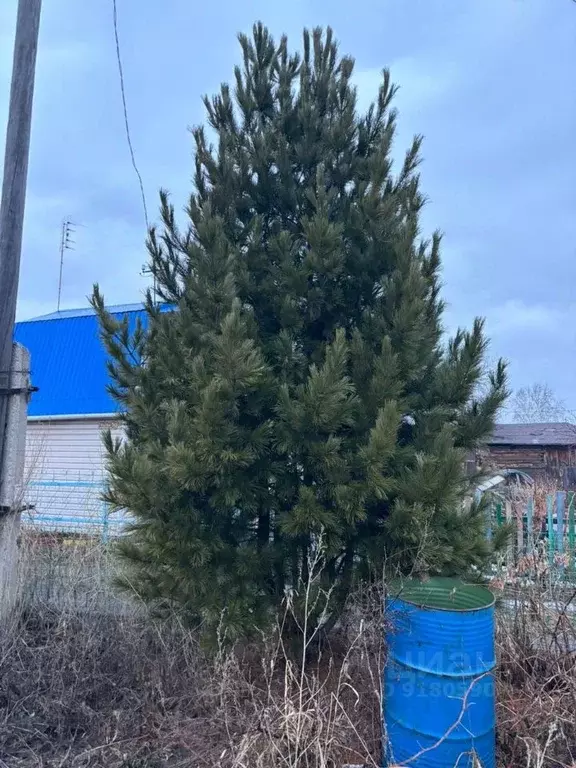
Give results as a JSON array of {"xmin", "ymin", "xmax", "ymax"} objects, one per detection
[{"xmin": 0, "ymin": 536, "xmax": 382, "ymax": 768}]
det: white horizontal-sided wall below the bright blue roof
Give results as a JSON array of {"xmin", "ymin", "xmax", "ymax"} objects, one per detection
[{"xmin": 23, "ymin": 418, "xmax": 123, "ymax": 536}]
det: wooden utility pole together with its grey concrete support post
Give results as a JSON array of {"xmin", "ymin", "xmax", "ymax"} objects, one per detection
[{"xmin": 0, "ymin": 0, "xmax": 42, "ymax": 620}]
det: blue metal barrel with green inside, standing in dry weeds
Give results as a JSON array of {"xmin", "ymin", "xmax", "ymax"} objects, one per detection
[{"xmin": 383, "ymin": 578, "xmax": 496, "ymax": 768}]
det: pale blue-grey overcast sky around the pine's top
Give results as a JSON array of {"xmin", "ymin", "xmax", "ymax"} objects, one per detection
[{"xmin": 0, "ymin": 0, "xmax": 576, "ymax": 406}]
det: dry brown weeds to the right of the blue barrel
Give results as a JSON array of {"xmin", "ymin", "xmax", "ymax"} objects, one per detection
[{"xmin": 497, "ymin": 581, "xmax": 576, "ymax": 768}]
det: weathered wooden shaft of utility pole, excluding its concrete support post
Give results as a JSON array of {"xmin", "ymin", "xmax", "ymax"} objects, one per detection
[{"xmin": 0, "ymin": 0, "xmax": 42, "ymax": 486}]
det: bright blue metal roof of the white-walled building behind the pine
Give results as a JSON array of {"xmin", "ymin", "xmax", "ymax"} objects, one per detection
[{"xmin": 14, "ymin": 304, "xmax": 147, "ymax": 417}]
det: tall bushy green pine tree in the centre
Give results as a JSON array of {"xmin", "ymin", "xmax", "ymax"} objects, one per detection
[{"xmin": 94, "ymin": 24, "xmax": 506, "ymax": 632}]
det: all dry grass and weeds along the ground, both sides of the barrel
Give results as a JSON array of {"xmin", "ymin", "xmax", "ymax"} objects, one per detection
[{"xmin": 0, "ymin": 536, "xmax": 576, "ymax": 768}]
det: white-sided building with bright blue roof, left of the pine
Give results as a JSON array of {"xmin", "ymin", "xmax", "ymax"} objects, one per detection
[{"xmin": 14, "ymin": 304, "xmax": 147, "ymax": 536}]
